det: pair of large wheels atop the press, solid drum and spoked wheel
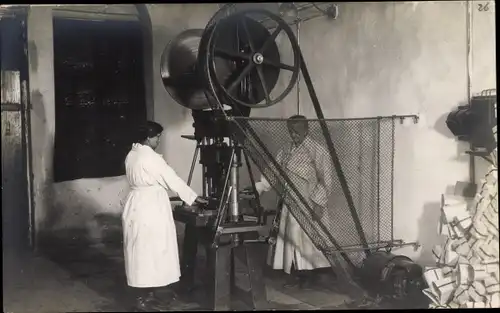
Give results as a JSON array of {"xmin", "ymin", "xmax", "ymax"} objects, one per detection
[{"xmin": 161, "ymin": 10, "xmax": 300, "ymax": 110}]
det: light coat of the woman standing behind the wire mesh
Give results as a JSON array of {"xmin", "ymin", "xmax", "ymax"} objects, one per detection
[{"xmin": 255, "ymin": 137, "xmax": 332, "ymax": 273}]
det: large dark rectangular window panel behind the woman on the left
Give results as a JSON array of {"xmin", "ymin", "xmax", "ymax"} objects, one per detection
[{"xmin": 53, "ymin": 18, "xmax": 146, "ymax": 182}]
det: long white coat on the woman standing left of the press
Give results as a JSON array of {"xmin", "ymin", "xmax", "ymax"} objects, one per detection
[{"xmin": 122, "ymin": 143, "xmax": 197, "ymax": 288}]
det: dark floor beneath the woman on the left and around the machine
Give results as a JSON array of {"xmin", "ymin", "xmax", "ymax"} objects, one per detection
[{"xmin": 4, "ymin": 228, "xmax": 428, "ymax": 313}]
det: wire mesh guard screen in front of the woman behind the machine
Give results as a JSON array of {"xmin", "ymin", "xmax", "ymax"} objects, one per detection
[{"xmin": 232, "ymin": 118, "xmax": 394, "ymax": 266}]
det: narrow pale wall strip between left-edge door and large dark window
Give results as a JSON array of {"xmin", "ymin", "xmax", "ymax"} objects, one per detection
[{"xmin": 27, "ymin": 7, "xmax": 55, "ymax": 230}]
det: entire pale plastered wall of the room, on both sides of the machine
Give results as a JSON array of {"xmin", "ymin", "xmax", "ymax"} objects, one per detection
[{"xmin": 28, "ymin": 1, "xmax": 496, "ymax": 262}]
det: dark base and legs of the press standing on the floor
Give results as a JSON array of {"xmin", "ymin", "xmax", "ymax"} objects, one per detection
[{"xmin": 181, "ymin": 224, "xmax": 268, "ymax": 311}]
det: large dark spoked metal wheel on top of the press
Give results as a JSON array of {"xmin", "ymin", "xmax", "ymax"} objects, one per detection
[{"xmin": 199, "ymin": 10, "xmax": 300, "ymax": 108}]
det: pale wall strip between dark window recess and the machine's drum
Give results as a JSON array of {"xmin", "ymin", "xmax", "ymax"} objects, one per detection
[{"xmin": 148, "ymin": 3, "xmax": 218, "ymax": 196}]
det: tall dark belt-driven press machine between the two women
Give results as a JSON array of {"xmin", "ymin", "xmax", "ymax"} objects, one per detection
[{"xmin": 161, "ymin": 4, "xmax": 372, "ymax": 310}]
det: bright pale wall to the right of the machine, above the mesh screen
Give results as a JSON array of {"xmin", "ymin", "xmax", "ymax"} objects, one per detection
[{"xmin": 256, "ymin": 1, "xmax": 496, "ymax": 263}]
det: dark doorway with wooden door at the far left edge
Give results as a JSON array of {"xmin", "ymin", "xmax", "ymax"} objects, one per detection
[{"xmin": 0, "ymin": 14, "xmax": 33, "ymax": 255}]
